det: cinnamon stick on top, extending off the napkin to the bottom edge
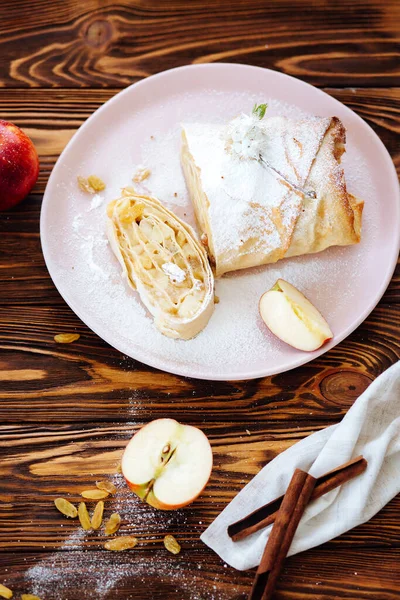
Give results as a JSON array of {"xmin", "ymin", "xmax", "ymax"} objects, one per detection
[{"xmin": 249, "ymin": 469, "xmax": 316, "ymax": 600}]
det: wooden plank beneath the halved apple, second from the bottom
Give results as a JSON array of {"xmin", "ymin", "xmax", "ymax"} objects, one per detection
[{"xmin": 0, "ymin": 419, "xmax": 400, "ymax": 552}]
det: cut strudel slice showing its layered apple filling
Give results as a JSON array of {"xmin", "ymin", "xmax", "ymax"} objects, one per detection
[{"xmin": 107, "ymin": 190, "xmax": 214, "ymax": 340}]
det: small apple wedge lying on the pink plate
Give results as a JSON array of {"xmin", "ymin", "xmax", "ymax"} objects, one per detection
[{"xmin": 260, "ymin": 279, "xmax": 333, "ymax": 352}]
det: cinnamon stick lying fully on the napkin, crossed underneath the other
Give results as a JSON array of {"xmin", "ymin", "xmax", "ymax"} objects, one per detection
[{"xmin": 228, "ymin": 456, "xmax": 367, "ymax": 542}]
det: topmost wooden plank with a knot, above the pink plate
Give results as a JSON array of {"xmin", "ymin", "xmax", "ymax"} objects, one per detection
[{"xmin": 0, "ymin": 0, "xmax": 400, "ymax": 88}]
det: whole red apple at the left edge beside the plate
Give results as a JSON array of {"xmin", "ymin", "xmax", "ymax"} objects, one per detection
[{"xmin": 0, "ymin": 119, "xmax": 39, "ymax": 210}]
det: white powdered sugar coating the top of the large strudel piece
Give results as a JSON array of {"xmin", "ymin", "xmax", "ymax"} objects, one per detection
[{"xmin": 183, "ymin": 115, "xmax": 330, "ymax": 273}]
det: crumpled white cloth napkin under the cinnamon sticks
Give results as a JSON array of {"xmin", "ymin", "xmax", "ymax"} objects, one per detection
[{"xmin": 201, "ymin": 361, "xmax": 400, "ymax": 570}]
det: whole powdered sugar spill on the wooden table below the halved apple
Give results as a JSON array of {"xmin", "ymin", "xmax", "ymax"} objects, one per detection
[{"xmin": 24, "ymin": 474, "xmax": 243, "ymax": 600}]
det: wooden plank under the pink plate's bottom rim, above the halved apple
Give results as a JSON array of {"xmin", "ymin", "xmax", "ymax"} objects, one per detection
[{"xmin": 0, "ymin": 304, "xmax": 400, "ymax": 422}]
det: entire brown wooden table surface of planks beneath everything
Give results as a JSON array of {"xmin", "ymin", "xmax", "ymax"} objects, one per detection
[{"xmin": 0, "ymin": 0, "xmax": 400, "ymax": 600}]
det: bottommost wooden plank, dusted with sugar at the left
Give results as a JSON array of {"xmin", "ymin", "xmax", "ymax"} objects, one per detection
[{"xmin": 0, "ymin": 541, "xmax": 400, "ymax": 600}]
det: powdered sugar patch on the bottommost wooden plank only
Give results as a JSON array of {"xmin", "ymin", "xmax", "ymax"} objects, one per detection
[{"xmin": 26, "ymin": 546, "xmax": 238, "ymax": 600}]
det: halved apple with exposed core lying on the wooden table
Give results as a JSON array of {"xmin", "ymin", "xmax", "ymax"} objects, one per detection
[{"xmin": 122, "ymin": 419, "xmax": 213, "ymax": 510}]
